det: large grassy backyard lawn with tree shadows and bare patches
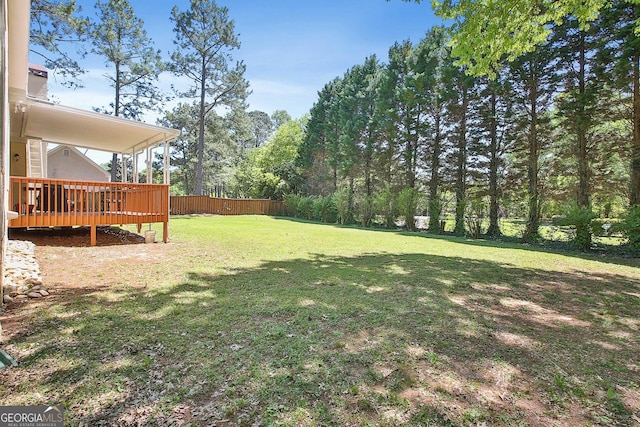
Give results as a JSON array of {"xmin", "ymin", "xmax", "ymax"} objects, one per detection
[{"xmin": 0, "ymin": 216, "xmax": 640, "ymax": 426}]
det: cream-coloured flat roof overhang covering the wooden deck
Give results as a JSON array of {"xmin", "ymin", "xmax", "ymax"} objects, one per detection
[{"xmin": 11, "ymin": 98, "xmax": 180, "ymax": 154}]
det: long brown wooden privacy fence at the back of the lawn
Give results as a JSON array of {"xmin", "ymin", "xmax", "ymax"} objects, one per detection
[{"xmin": 171, "ymin": 196, "xmax": 284, "ymax": 215}]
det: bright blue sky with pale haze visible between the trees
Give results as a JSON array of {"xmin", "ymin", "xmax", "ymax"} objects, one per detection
[{"xmin": 49, "ymin": 0, "xmax": 441, "ymax": 122}]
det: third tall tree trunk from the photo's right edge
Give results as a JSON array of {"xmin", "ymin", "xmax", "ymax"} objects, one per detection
[{"xmin": 523, "ymin": 67, "xmax": 540, "ymax": 241}]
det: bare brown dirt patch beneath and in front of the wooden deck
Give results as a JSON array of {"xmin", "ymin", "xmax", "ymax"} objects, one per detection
[{"xmin": 0, "ymin": 227, "xmax": 172, "ymax": 341}]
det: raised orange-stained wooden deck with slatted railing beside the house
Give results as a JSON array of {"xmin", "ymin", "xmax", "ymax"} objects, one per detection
[{"xmin": 9, "ymin": 176, "xmax": 169, "ymax": 245}]
